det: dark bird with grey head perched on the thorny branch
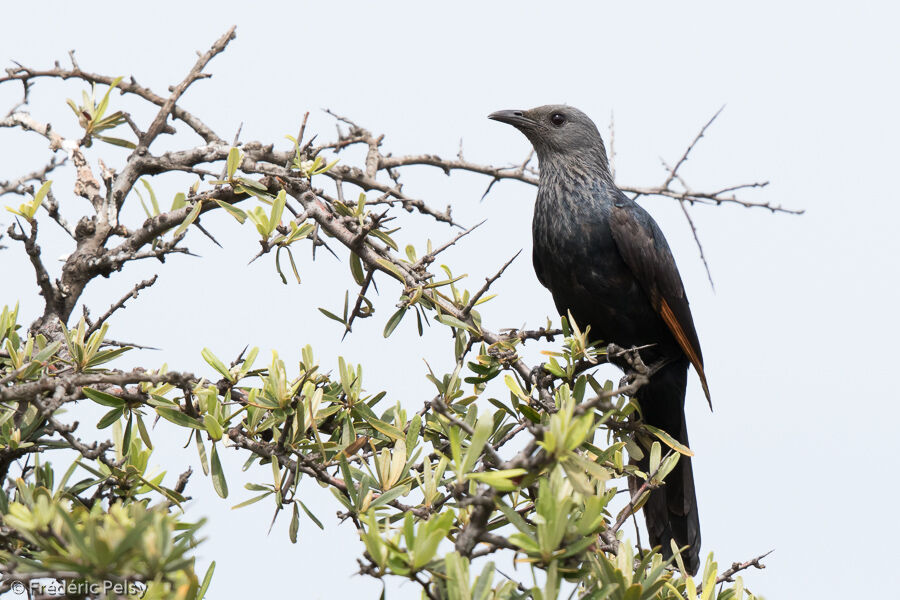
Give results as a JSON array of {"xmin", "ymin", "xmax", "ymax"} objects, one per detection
[{"xmin": 488, "ymin": 104, "xmax": 712, "ymax": 575}]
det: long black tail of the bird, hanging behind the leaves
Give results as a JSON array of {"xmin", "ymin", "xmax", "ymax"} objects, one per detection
[{"xmin": 631, "ymin": 358, "xmax": 700, "ymax": 575}]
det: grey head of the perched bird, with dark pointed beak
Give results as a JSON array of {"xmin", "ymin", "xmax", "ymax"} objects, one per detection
[{"xmin": 488, "ymin": 104, "xmax": 607, "ymax": 169}]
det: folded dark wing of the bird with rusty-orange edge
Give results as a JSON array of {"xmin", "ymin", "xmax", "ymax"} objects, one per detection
[{"xmin": 609, "ymin": 201, "xmax": 712, "ymax": 408}]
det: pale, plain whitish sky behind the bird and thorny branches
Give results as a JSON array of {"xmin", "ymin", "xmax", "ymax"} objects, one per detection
[{"xmin": 0, "ymin": 2, "xmax": 900, "ymax": 598}]
